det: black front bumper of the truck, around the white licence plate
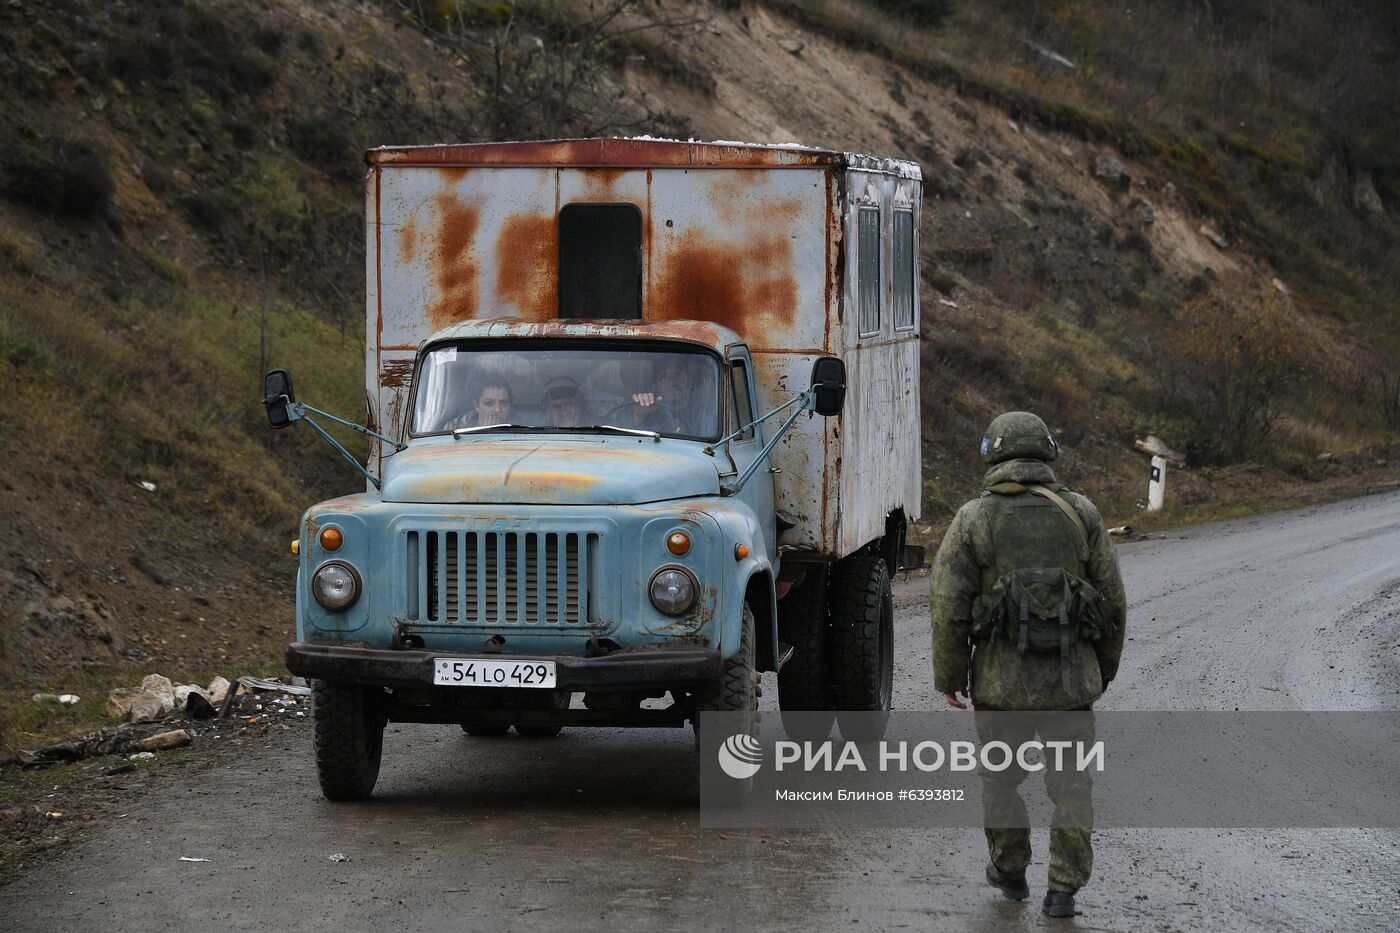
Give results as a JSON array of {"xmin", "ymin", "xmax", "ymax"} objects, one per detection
[{"xmin": 287, "ymin": 642, "xmax": 720, "ymax": 691}]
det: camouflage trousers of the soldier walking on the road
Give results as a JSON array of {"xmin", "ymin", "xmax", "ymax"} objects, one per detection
[{"xmin": 976, "ymin": 710, "xmax": 1093, "ymax": 894}]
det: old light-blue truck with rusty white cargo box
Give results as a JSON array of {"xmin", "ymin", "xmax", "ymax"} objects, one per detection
[{"xmin": 265, "ymin": 139, "xmax": 921, "ymax": 800}]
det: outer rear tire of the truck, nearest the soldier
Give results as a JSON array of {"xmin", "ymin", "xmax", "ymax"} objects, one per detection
[{"xmin": 832, "ymin": 553, "xmax": 895, "ymax": 741}]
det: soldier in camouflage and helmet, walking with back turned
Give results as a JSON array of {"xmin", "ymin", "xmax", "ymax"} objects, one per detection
[{"xmin": 931, "ymin": 412, "xmax": 1127, "ymax": 916}]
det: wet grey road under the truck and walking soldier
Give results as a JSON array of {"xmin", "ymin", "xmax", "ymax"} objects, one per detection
[{"xmin": 0, "ymin": 495, "xmax": 1400, "ymax": 933}]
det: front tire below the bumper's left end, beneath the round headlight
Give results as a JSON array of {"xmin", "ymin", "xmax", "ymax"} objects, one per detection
[{"xmin": 312, "ymin": 681, "xmax": 386, "ymax": 801}]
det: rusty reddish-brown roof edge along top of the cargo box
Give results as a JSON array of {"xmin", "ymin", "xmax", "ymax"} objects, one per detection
[{"xmin": 364, "ymin": 136, "xmax": 923, "ymax": 181}]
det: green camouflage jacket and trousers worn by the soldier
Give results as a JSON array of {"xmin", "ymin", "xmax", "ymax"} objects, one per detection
[{"xmin": 931, "ymin": 451, "xmax": 1127, "ymax": 894}]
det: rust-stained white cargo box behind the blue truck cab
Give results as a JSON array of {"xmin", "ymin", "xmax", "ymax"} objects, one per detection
[{"xmin": 365, "ymin": 139, "xmax": 921, "ymax": 559}]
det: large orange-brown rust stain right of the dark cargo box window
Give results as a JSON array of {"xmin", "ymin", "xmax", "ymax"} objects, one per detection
[{"xmin": 647, "ymin": 233, "xmax": 798, "ymax": 336}]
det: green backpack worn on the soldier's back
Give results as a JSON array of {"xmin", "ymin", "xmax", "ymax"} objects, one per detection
[{"xmin": 973, "ymin": 483, "xmax": 1109, "ymax": 692}]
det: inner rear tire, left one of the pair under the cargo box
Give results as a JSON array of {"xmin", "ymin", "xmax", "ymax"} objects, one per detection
[{"xmin": 778, "ymin": 565, "xmax": 836, "ymax": 741}]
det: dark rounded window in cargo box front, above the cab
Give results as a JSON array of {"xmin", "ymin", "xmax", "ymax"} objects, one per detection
[{"xmin": 559, "ymin": 205, "xmax": 641, "ymax": 321}]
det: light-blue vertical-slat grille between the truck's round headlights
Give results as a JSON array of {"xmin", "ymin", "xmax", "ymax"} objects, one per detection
[{"xmin": 406, "ymin": 531, "xmax": 599, "ymax": 625}]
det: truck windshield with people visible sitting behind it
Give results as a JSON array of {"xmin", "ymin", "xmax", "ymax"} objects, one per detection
[{"xmin": 412, "ymin": 343, "xmax": 721, "ymax": 440}]
